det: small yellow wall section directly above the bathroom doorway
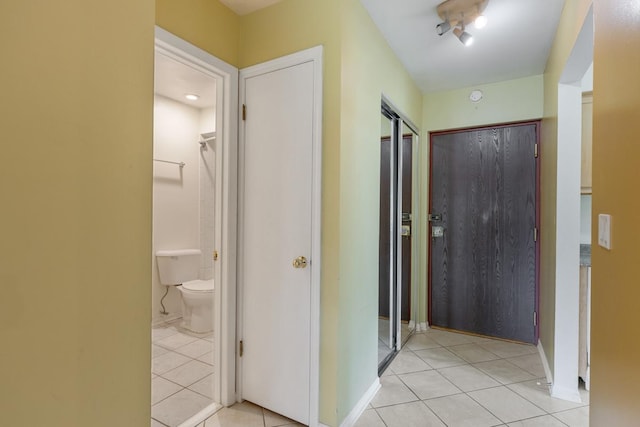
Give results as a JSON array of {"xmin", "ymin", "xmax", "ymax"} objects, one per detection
[{"xmin": 156, "ymin": 0, "xmax": 240, "ymax": 67}]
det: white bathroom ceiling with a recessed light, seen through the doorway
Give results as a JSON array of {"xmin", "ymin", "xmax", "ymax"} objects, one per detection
[{"xmin": 154, "ymin": 52, "xmax": 216, "ymax": 108}]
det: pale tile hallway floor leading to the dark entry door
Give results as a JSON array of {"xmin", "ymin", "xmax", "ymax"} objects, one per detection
[{"xmin": 356, "ymin": 329, "xmax": 589, "ymax": 427}]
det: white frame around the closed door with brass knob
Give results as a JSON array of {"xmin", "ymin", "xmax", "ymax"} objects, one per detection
[{"xmin": 238, "ymin": 46, "xmax": 323, "ymax": 427}]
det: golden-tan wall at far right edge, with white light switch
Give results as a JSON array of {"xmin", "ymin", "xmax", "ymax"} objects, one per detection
[{"xmin": 590, "ymin": 0, "xmax": 640, "ymax": 427}]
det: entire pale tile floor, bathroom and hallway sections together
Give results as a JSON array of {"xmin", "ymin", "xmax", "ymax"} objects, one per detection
[{"xmin": 151, "ymin": 324, "xmax": 589, "ymax": 427}]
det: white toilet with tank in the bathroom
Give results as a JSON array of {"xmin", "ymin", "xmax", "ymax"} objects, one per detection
[{"xmin": 156, "ymin": 249, "xmax": 214, "ymax": 334}]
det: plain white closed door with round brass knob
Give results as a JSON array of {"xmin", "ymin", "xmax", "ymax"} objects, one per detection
[{"xmin": 240, "ymin": 51, "xmax": 319, "ymax": 424}]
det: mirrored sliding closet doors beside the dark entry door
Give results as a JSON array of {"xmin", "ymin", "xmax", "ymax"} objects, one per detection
[{"xmin": 378, "ymin": 100, "xmax": 418, "ymax": 373}]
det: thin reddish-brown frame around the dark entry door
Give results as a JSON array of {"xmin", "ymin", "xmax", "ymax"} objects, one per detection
[{"xmin": 427, "ymin": 119, "xmax": 542, "ymax": 343}]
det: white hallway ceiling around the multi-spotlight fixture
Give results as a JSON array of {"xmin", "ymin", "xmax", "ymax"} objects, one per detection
[{"xmin": 360, "ymin": 0, "xmax": 564, "ymax": 93}]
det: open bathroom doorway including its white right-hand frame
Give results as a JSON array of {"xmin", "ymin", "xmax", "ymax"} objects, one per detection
[{"xmin": 150, "ymin": 28, "xmax": 237, "ymax": 427}]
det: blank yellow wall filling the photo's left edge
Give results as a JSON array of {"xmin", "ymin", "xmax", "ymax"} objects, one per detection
[{"xmin": 0, "ymin": 0, "xmax": 154, "ymax": 427}]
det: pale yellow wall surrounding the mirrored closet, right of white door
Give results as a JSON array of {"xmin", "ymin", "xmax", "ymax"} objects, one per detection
[{"xmin": 332, "ymin": 0, "xmax": 422, "ymax": 421}]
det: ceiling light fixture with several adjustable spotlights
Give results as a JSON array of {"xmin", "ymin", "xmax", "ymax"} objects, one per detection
[{"xmin": 436, "ymin": 0, "xmax": 489, "ymax": 46}]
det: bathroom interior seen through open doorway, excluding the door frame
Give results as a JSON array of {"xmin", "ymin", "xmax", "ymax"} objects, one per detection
[{"xmin": 150, "ymin": 50, "xmax": 220, "ymax": 426}]
